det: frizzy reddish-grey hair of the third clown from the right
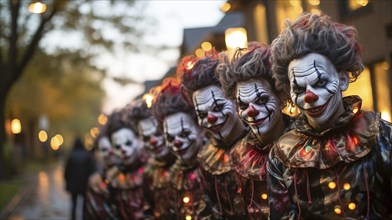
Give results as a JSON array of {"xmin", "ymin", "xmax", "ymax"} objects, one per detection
[{"xmin": 177, "ymin": 48, "xmax": 220, "ymax": 100}]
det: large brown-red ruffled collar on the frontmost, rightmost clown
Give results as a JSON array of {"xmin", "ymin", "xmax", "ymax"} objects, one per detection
[{"xmin": 275, "ymin": 96, "xmax": 380, "ymax": 169}]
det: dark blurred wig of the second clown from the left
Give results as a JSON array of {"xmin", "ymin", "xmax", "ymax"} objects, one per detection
[{"xmin": 106, "ymin": 106, "xmax": 138, "ymax": 140}]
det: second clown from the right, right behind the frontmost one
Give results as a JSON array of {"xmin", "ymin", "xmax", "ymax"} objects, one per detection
[{"xmin": 217, "ymin": 43, "xmax": 289, "ymax": 219}]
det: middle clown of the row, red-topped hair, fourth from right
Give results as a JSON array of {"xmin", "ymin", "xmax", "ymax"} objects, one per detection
[{"xmin": 153, "ymin": 79, "xmax": 212, "ymax": 220}]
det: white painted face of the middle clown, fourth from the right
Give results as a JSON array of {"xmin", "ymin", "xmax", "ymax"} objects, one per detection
[{"xmin": 163, "ymin": 112, "xmax": 202, "ymax": 161}]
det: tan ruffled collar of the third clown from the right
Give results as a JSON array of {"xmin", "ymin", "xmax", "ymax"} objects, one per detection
[{"xmin": 197, "ymin": 130, "xmax": 248, "ymax": 175}]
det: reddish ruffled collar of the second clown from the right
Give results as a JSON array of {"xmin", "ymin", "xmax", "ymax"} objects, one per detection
[{"xmin": 231, "ymin": 132, "xmax": 272, "ymax": 181}]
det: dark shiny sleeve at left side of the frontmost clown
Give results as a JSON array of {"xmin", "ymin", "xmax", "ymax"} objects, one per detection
[{"xmin": 267, "ymin": 150, "xmax": 297, "ymax": 220}]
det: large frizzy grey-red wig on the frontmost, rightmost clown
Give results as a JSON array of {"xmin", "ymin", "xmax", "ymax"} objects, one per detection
[{"xmin": 271, "ymin": 13, "xmax": 364, "ymax": 99}]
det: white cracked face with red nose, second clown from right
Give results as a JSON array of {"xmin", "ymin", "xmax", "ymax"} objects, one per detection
[{"xmin": 236, "ymin": 79, "xmax": 282, "ymax": 137}]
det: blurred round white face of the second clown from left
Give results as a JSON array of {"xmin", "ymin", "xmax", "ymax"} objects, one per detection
[{"xmin": 112, "ymin": 128, "xmax": 142, "ymax": 164}]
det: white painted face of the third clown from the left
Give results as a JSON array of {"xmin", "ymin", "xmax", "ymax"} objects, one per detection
[{"xmin": 138, "ymin": 117, "xmax": 170, "ymax": 158}]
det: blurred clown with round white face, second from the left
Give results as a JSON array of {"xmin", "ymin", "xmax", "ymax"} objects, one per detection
[{"xmin": 107, "ymin": 107, "xmax": 149, "ymax": 219}]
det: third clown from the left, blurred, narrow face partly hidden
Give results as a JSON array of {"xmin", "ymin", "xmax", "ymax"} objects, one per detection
[{"xmin": 130, "ymin": 99, "xmax": 175, "ymax": 220}]
